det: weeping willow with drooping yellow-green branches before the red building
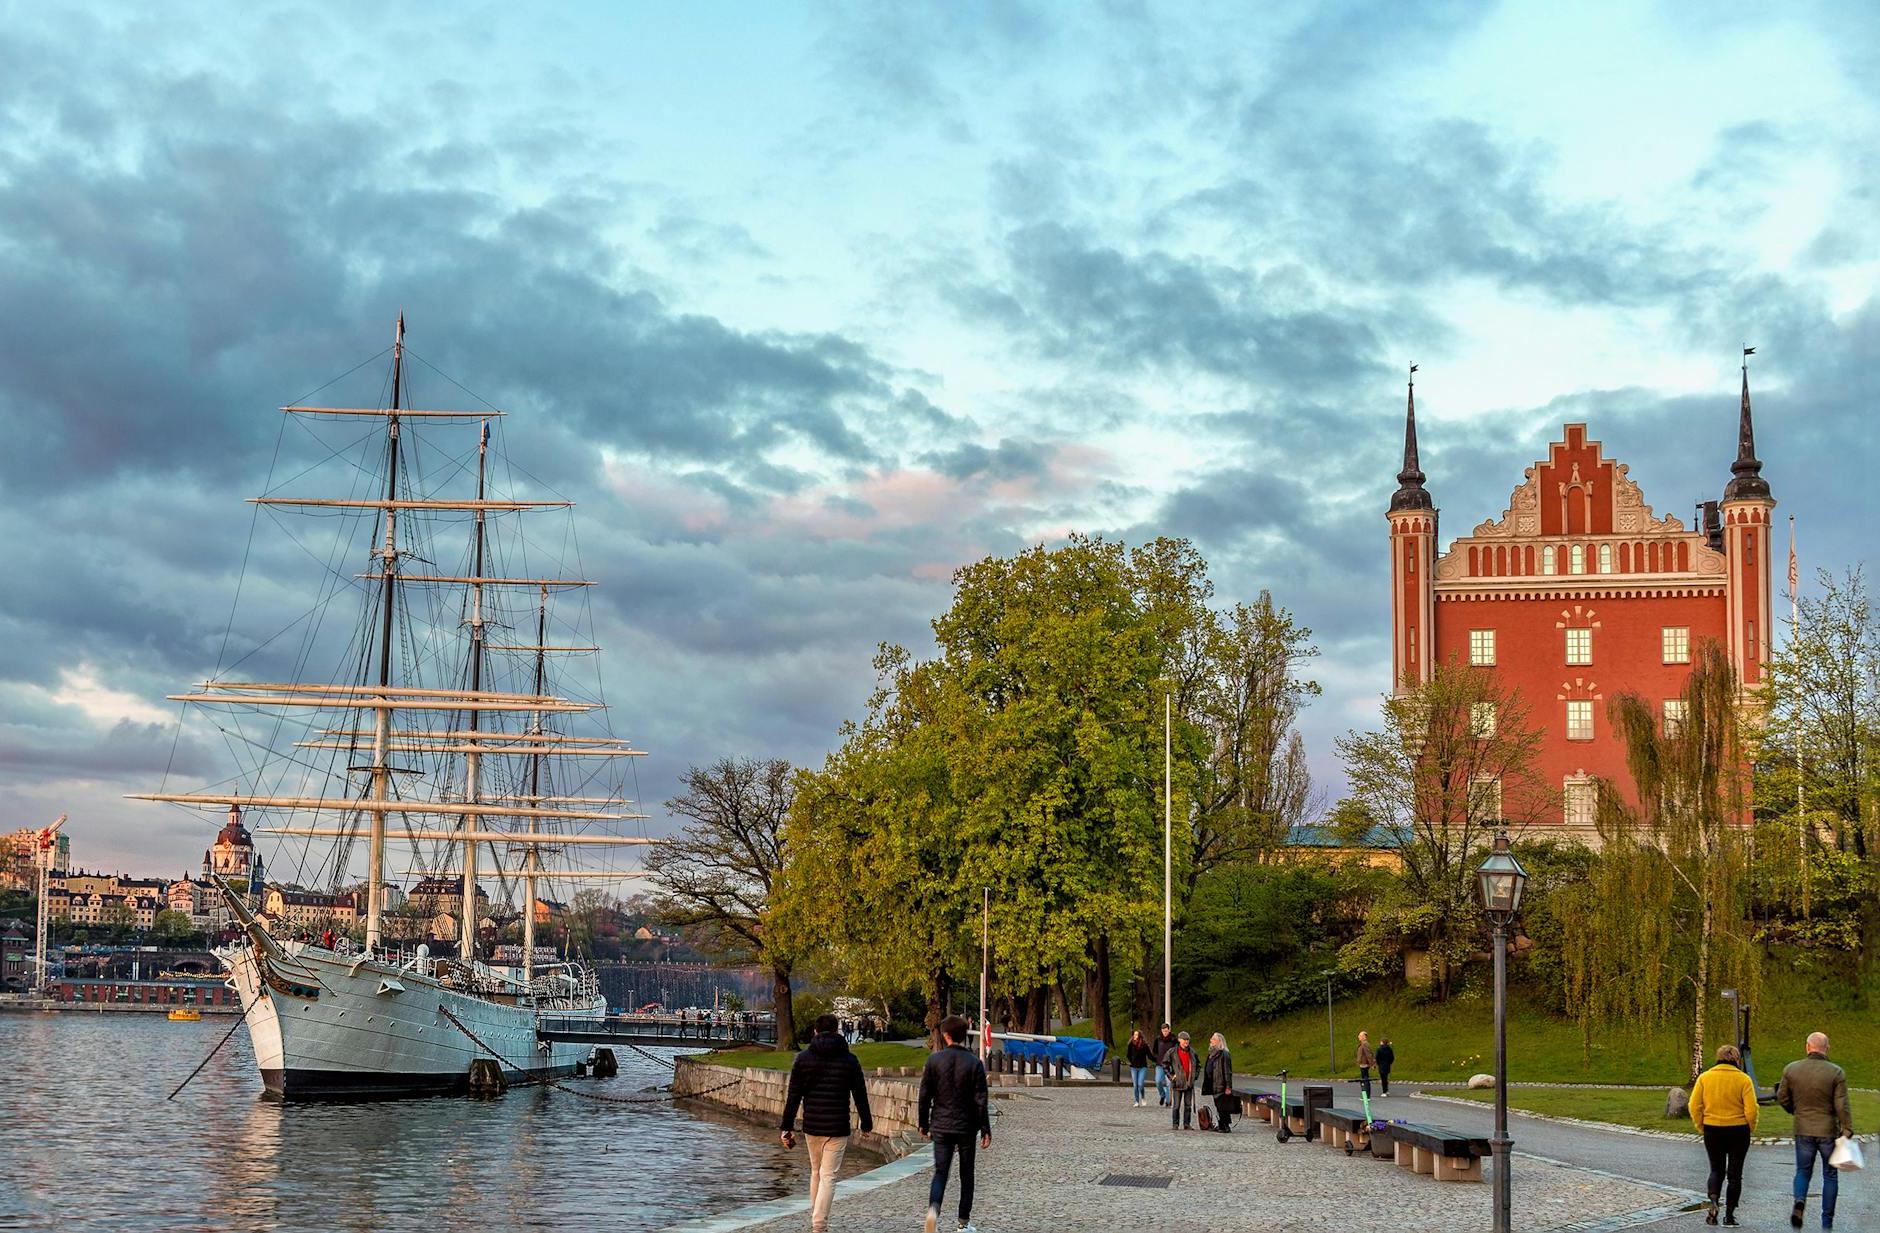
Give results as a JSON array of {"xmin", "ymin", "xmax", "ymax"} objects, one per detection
[{"xmin": 1560, "ymin": 643, "xmax": 1758, "ymax": 1075}]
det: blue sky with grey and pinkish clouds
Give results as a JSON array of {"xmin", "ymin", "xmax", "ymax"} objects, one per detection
[{"xmin": 0, "ymin": 0, "xmax": 1880, "ymax": 874}]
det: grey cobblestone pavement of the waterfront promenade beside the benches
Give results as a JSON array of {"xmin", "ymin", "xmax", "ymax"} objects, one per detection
[{"xmin": 733, "ymin": 1086, "xmax": 1690, "ymax": 1233}]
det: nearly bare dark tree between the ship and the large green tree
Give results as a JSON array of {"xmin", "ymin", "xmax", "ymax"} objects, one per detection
[{"xmin": 647, "ymin": 757, "xmax": 795, "ymax": 1047}]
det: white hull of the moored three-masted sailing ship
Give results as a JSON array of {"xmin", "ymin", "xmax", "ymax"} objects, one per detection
[{"xmin": 220, "ymin": 944, "xmax": 605, "ymax": 1100}]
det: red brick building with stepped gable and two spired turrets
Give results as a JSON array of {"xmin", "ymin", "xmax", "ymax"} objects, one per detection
[{"xmin": 1387, "ymin": 367, "xmax": 1775, "ymax": 838}]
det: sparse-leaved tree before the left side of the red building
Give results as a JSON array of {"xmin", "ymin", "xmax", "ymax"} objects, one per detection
[{"xmin": 1339, "ymin": 660, "xmax": 1557, "ymax": 1000}]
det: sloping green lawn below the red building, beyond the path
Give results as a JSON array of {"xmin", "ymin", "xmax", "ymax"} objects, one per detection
[{"xmin": 1203, "ymin": 970, "xmax": 1880, "ymax": 1086}]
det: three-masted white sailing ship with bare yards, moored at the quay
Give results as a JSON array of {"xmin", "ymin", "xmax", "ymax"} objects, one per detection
[{"xmin": 137, "ymin": 314, "xmax": 654, "ymax": 1100}]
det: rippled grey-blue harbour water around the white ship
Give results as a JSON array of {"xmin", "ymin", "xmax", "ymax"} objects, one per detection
[{"xmin": 0, "ymin": 1013, "xmax": 830, "ymax": 1231}]
